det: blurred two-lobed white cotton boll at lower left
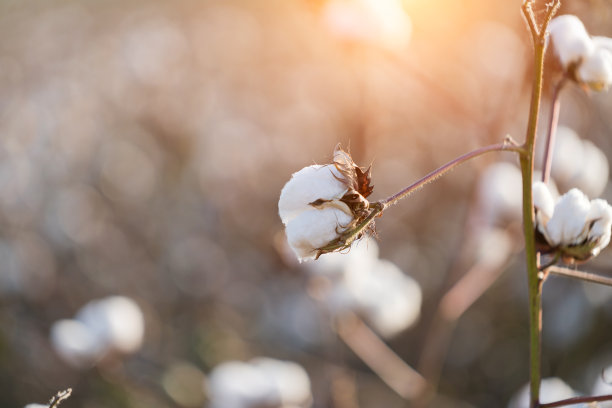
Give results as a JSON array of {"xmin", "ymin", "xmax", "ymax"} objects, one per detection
[{"xmin": 51, "ymin": 296, "xmax": 144, "ymax": 368}]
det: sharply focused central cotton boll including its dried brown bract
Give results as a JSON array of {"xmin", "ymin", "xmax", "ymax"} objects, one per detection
[{"xmin": 278, "ymin": 147, "xmax": 372, "ymax": 262}]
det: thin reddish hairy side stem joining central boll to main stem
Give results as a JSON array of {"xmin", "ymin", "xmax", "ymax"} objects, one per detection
[{"xmin": 380, "ymin": 139, "xmax": 523, "ymax": 208}]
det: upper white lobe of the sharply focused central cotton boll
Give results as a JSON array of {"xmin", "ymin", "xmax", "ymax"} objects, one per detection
[{"xmin": 278, "ymin": 164, "xmax": 347, "ymax": 225}]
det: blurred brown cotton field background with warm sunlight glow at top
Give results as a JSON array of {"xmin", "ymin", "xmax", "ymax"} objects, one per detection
[{"xmin": 0, "ymin": 0, "xmax": 612, "ymax": 408}]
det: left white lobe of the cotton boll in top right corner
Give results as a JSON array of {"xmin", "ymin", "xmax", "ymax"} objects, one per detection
[{"xmin": 548, "ymin": 14, "xmax": 594, "ymax": 69}]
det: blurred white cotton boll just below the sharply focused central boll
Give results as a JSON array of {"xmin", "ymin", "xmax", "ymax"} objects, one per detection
[{"xmin": 346, "ymin": 260, "xmax": 422, "ymax": 337}]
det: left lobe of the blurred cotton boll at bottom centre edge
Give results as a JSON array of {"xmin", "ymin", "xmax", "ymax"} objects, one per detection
[{"xmin": 205, "ymin": 361, "xmax": 280, "ymax": 408}]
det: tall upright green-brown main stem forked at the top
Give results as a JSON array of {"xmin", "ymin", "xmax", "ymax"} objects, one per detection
[{"xmin": 520, "ymin": 0, "xmax": 560, "ymax": 408}]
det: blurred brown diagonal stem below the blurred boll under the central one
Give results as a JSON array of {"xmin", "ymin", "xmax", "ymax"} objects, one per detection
[{"xmin": 337, "ymin": 314, "xmax": 427, "ymax": 400}]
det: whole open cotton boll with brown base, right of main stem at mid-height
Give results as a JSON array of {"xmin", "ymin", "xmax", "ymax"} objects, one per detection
[{"xmin": 533, "ymin": 182, "xmax": 612, "ymax": 263}]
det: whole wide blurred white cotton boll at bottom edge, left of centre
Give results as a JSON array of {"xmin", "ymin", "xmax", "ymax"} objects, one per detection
[{"xmin": 205, "ymin": 358, "xmax": 312, "ymax": 408}]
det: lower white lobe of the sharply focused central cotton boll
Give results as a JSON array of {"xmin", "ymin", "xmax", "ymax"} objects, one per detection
[{"xmin": 286, "ymin": 208, "xmax": 353, "ymax": 262}]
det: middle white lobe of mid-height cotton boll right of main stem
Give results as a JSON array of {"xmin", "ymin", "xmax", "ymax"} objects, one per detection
[{"xmin": 546, "ymin": 188, "xmax": 591, "ymax": 245}]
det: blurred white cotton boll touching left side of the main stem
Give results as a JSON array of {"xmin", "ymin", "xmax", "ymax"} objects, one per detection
[{"xmin": 478, "ymin": 162, "xmax": 522, "ymax": 224}]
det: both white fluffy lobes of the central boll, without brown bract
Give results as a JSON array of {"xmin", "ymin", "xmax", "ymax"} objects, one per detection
[{"xmin": 278, "ymin": 164, "xmax": 354, "ymax": 262}]
